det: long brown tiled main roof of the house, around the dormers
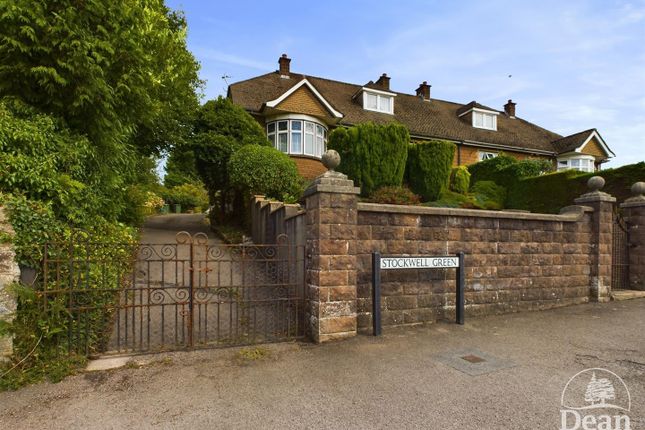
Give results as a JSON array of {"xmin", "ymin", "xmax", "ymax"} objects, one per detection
[{"xmin": 229, "ymin": 72, "xmax": 562, "ymax": 153}]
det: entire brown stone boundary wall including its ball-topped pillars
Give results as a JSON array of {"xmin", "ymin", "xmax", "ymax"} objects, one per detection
[{"xmin": 247, "ymin": 158, "xmax": 645, "ymax": 342}]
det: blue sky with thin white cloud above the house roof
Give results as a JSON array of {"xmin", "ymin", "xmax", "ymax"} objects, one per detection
[{"xmin": 167, "ymin": 0, "xmax": 645, "ymax": 167}]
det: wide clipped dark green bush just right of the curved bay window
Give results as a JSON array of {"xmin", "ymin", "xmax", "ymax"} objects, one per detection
[{"xmin": 327, "ymin": 123, "xmax": 410, "ymax": 196}]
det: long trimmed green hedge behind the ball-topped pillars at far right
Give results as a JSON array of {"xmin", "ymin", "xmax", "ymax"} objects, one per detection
[{"xmin": 506, "ymin": 162, "xmax": 645, "ymax": 213}]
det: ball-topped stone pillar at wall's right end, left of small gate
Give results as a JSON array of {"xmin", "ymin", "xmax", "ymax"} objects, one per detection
[{"xmin": 574, "ymin": 176, "xmax": 616, "ymax": 302}]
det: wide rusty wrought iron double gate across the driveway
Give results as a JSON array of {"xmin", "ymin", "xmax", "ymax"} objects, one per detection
[{"xmin": 36, "ymin": 232, "xmax": 305, "ymax": 355}]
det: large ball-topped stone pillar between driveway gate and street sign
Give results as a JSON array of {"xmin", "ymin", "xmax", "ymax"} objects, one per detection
[{"xmin": 305, "ymin": 150, "xmax": 360, "ymax": 343}]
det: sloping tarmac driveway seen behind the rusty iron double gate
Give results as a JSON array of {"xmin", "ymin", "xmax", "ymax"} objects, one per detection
[{"xmin": 107, "ymin": 214, "xmax": 302, "ymax": 354}]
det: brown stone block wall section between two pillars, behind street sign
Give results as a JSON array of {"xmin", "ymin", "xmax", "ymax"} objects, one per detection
[{"xmin": 355, "ymin": 203, "xmax": 593, "ymax": 330}]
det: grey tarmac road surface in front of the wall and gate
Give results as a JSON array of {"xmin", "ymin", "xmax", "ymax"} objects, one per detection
[{"xmin": 0, "ymin": 299, "xmax": 645, "ymax": 429}]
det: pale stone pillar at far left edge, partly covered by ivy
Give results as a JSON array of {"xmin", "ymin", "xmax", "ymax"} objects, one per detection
[{"xmin": 0, "ymin": 206, "xmax": 20, "ymax": 362}]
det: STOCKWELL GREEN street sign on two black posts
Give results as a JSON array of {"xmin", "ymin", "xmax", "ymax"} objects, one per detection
[{"xmin": 372, "ymin": 252, "xmax": 466, "ymax": 336}]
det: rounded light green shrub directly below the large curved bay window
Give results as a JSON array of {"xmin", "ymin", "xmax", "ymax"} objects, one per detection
[{"xmin": 228, "ymin": 145, "xmax": 302, "ymax": 202}]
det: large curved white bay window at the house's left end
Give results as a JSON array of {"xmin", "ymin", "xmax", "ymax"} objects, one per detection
[{"xmin": 265, "ymin": 115, "xmax": 328, "ymax": 158}]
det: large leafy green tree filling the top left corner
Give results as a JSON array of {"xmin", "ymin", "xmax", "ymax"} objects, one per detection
[{"xmin": 0, "ymin": 0, "xmax": 200, "ymax": 159}]
